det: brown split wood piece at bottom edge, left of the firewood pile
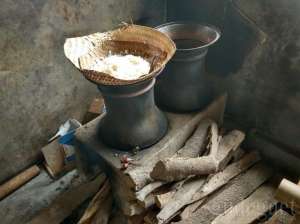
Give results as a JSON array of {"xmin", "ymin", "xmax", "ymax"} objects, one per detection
[{"xmin": 78, "ymin": 180, "xmax": 112, "ymax": 224}]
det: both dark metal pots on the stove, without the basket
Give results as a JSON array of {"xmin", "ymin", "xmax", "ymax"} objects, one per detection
[{"xmin": 98, "ymin": 22, "xmax": 220, "ymax": 150}]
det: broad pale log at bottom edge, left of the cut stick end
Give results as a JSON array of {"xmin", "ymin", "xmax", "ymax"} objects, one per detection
[{"xmin": 212, "ymin": 184, "xmax": 277, "ymax": 224}]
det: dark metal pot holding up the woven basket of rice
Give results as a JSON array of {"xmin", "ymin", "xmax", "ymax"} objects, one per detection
[{"xmin": 98, "ymin": 79, "xmax": 168, "ymax": 151}]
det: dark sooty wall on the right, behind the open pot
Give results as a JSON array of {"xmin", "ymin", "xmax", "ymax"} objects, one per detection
[{"xmin": 168, "ymin": 0, "xmax": 300, "ymax": 152}]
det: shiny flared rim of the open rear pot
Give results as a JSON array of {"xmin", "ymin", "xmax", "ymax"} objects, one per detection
[{"xmin": 155, "ymin": 21, "xmax": 222, "ymax": 52}]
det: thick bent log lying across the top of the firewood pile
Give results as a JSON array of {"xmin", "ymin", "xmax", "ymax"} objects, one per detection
[{"xmin": 151, "ymin": 130, "xmax": 245, "ymax": 182}]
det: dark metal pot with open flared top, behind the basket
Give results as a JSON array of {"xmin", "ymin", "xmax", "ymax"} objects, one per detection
[{"xmin": 155, "ymin": 22, "xmax": 220, "ymax": 112}]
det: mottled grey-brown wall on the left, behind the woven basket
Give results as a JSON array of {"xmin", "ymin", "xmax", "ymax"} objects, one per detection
[{"xmin": 0, "ymin": 0, "xmax": 166, "ymax": 182}]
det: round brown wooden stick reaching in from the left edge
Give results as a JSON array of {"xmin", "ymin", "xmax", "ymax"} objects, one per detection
[{"xmin": 0, "ymin": 165, "xmax": 40, "ymax": 200}]
